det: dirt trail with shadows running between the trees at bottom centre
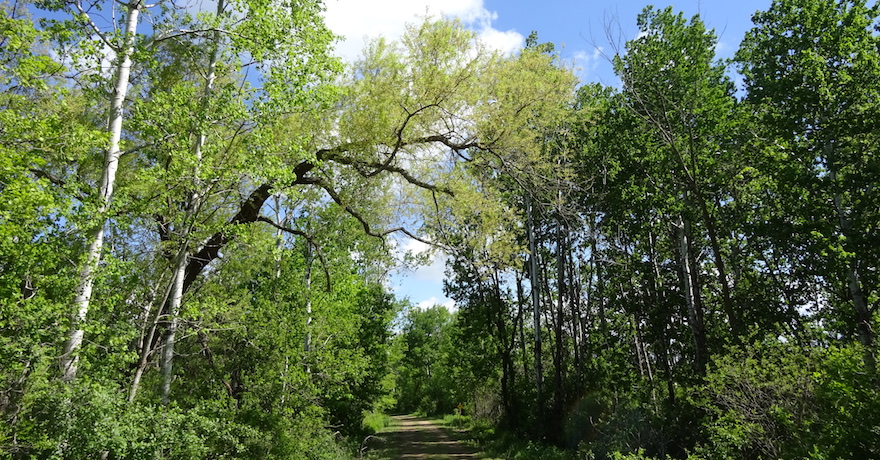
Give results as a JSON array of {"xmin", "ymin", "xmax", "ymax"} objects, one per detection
[{"xmin": 372, "ymin": 415, "xmax": 484, "ymax": 460}]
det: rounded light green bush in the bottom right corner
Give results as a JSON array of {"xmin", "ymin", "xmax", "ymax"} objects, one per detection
[{"xmin": 696, "ymin": 337, "xmax": 880, "ymax": 459}]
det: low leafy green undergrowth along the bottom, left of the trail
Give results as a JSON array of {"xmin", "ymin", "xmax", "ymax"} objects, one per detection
[{"xmin": 4, "ymin": 374, "xmax": 344, "ymax": 459}]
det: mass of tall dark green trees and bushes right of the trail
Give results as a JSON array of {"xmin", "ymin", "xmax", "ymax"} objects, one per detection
[{"xmin": 434, "ymin": 0, "xmax": 878, "ymax": 458}]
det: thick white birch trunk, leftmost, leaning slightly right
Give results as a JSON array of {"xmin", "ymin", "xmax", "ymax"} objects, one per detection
[{"xmin": 60, "ymin": 0, "xmax": 143, "ymax": 382}]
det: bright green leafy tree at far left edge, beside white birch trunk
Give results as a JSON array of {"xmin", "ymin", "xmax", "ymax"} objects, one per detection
[{"xmin": 0, "ymin": 3, "xmax": 103, "ymax": 450}]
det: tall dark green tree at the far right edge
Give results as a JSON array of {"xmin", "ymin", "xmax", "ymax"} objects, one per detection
[{"xmin": 737, "ymin": 0, "xmax": 880, "ymax": 368}]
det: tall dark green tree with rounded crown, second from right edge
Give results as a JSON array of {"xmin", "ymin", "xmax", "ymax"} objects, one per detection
[{"xmin": 615, "ymin": 8, "xmax": 742, "ymax": 372}]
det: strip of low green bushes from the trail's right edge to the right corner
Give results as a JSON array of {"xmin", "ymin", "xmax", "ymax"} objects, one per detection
[{"xmin": 432, "ymin": 337, "xmax": 880, "ymax": 460}]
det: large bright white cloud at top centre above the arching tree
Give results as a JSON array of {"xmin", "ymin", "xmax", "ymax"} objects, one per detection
[{"xmin": 324, "ymin": 0, "xmax": 524, "ymax": 61}]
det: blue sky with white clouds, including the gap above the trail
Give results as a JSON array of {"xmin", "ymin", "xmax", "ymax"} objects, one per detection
[{"xmin": 325, "ymin": 0, "xmax": 771, "ymax": 308}]
